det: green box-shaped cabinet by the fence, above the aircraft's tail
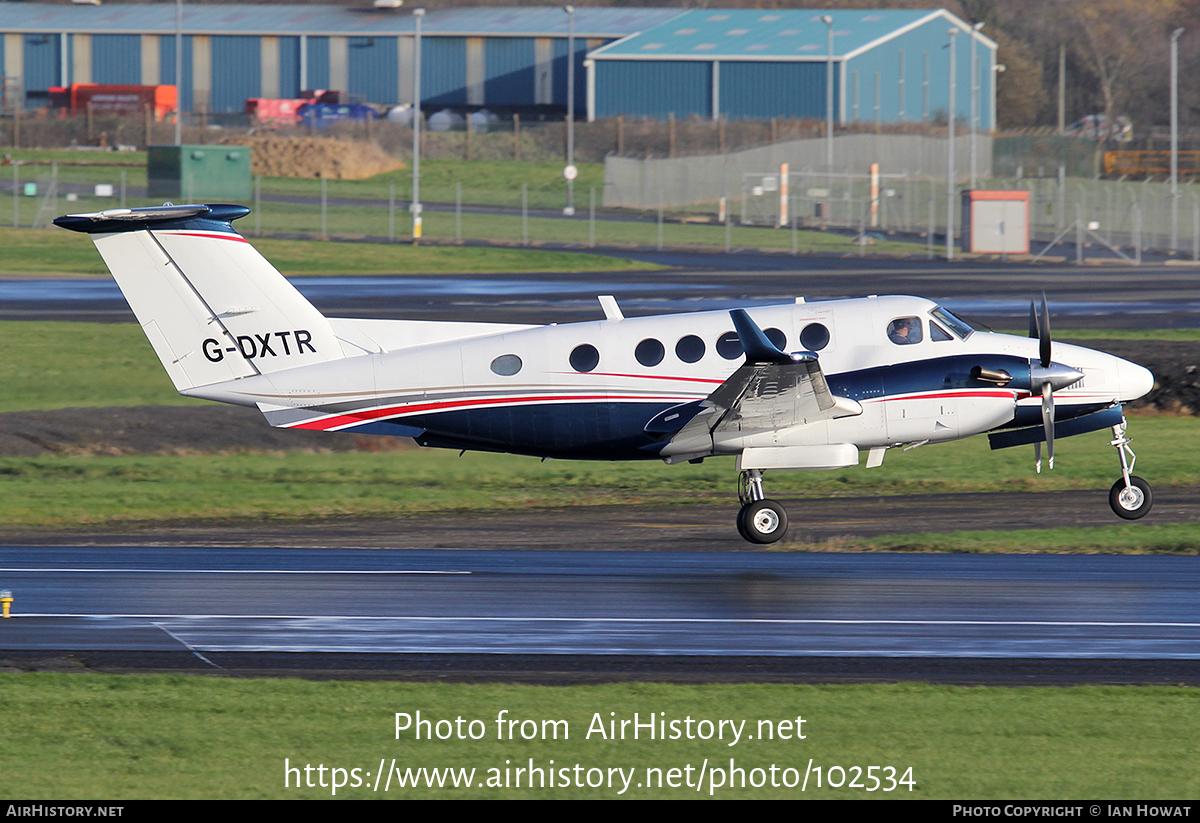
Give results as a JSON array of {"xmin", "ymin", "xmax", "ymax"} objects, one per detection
[{"xmin": 146, "ymin": 145, "xmax": 251, "ymax": 203}]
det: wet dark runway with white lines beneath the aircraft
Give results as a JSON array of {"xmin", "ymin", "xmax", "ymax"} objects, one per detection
[{"xmin": 0, "ymin": 547, "xmax": 1200, "ymax": 681}]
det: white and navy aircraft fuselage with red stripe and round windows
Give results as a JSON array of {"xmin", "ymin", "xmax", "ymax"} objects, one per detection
[{"xmin": 185, "ymin": 296, "xmax": 1152, "ymax": 459}]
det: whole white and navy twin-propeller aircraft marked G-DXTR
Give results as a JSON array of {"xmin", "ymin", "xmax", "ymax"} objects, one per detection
[{"xmin": 54, "ymin": 204, "xmax": 1153, "ymax": 543}]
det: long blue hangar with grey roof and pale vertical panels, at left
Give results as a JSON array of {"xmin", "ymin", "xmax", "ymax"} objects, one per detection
[{"xmin": 0, "ymin": 2, "xmax": 679, "ymax": 113}]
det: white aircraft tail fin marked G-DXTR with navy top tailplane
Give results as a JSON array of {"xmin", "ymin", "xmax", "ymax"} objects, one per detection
[{"xmin": 54, "ymin": 204, "xmax": 344, "ymax": 391}]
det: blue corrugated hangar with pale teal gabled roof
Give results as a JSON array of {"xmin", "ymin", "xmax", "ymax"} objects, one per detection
[{"xmin": 586, "ymin": 8, "xmax": 997, "ymax": 130}]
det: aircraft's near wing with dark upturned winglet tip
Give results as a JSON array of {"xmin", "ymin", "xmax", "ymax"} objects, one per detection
[{"xmin": 659, "ymin": 308, "xmax": 863, "ymax": 458}]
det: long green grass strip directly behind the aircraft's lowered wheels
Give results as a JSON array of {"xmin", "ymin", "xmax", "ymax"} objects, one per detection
[{"xmin": 0, "ymin": 416, "xmax": 1200, "ymax": 527}]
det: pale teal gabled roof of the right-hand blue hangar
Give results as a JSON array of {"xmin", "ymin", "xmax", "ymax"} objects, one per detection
[{"xmin": 588, "ymin": 8, "xmax": 995, "ymax": 60}]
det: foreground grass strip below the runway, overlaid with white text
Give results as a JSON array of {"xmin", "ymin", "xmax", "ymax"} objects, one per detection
[{"xmin": 0, "ymin": 673, "xmax": 1200, "ymax": 800}]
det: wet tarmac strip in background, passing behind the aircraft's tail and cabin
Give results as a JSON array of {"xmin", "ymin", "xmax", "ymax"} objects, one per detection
[{"xmin": 7, "ymin": 250, "xmax": 1200, "ymax": 329}]
